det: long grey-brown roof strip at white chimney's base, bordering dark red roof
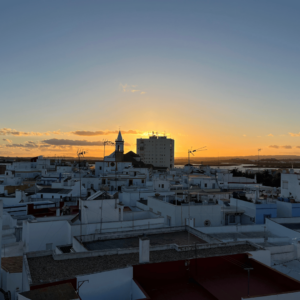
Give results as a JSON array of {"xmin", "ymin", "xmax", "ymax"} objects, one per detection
[{"xmin": 27, "ymin": 243, "xmax": 257, "ymax": 285}]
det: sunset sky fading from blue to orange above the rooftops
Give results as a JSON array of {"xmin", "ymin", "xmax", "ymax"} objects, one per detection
[{"xmin": 0, "ymin": 0, "xmax": 300, "ymax": 157}]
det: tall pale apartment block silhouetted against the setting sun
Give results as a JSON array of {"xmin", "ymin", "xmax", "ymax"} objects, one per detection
[{"xmin": 136, "ymin": 134, "xmax": 174, "ymax": 168}]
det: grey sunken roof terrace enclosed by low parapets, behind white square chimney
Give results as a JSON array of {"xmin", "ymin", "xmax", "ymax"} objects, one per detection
[{"xmin": 83, "ymin": 231, "xmax": 206, "ymax": 251}]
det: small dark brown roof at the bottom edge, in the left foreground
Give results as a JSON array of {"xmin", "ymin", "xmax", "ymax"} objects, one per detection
[{"xmin": 21, "ymin": 283, "xmax": 79, "ymax": 300}]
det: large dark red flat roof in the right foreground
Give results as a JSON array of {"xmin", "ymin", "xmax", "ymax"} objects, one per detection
[{"xmin": 133, "ymin": 254, "xmax": 300, "ymax": 300}]
